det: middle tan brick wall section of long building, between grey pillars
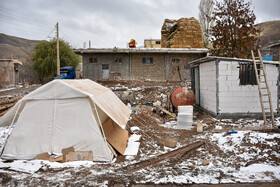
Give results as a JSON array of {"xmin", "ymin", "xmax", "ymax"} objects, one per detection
[{"xmin": 131, "ymin": 53, "xmax": 165, "ymax": 80}]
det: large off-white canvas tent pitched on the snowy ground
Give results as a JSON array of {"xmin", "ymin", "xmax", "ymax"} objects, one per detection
[{"xmin": 0, "ymin": 79, "xmax": 130, "ymax": 161}]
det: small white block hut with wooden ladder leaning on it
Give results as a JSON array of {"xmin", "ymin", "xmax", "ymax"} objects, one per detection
[{"xmin": 190, "ymin": 56, "xmax": 280, "ymax": 117}]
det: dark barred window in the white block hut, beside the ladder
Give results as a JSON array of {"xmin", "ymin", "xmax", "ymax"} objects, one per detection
[{"xmin": 239, "ymin": 64, "xmax": 259, "ymax": 85}]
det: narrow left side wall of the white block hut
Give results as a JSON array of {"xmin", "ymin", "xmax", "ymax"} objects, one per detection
[{"xmin": 199, "ymin": 60, "xmax": 217, "ymax": 113}]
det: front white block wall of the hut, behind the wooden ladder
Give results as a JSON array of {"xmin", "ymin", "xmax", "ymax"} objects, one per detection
[{"xmin": 218, "ymin": 61, "xmax": 278, "ymax": 114}]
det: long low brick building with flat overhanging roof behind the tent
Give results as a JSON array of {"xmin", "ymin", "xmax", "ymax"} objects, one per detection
[{"xmin": 74, "ymin": 47, "xmax": 208, "ymax": 81}]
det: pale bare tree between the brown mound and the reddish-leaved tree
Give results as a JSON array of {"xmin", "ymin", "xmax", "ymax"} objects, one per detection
[{"xmin": 198, "ymin": 0, "xmax": 213, "ymax": 47}]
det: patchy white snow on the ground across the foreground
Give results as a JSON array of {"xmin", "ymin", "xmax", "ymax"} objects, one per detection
[{"xmin": 0, "ymin": 118, "xmax": 280, "ymax": 186}]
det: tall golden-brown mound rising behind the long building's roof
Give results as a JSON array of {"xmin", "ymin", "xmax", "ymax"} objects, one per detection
[{"xmin": 161, "ymin": 17, "xmax": 204, "ymax": 48}]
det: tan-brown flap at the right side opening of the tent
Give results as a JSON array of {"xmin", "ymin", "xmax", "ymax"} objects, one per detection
[{"xmin": 102, "ymin": 118, "xmax": 129, "ymax": 155}]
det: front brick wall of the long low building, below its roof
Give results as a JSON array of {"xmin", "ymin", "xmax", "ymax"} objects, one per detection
[{"xmin": 82, "ymin": 53, "xmax": 205, "ymax": 81}]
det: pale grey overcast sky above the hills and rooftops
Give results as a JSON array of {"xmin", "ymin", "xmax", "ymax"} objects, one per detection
[{"xmin": 0, "ymin": 0, "xmax": 280, "ymax": 48}]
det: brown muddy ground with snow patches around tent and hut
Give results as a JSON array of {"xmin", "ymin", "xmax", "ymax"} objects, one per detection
[{"xmin": 0, "ymin": 81, "xmax": 280, "ymax": 186}]
